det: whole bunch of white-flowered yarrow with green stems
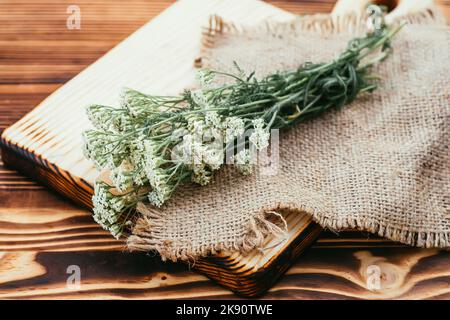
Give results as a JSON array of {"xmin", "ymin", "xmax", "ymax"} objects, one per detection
[{"xmin": 84, "ymin": 21, "xmax": 400, "ymax": 237}]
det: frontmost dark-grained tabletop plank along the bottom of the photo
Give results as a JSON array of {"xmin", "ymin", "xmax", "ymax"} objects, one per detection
[{"xmin": 0, "ymin": 247, "xmax": 450, "ymax": 299}]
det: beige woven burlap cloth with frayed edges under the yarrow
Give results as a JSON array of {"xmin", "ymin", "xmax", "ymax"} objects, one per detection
[{"xmin": 128, "ymin": 8, "xmax": 450, "ymax": 260}]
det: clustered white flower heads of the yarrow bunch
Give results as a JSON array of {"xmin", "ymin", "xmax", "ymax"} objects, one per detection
[{"xmin": 84, "ymin": 82, "xmax": 269, "ymax": 237}]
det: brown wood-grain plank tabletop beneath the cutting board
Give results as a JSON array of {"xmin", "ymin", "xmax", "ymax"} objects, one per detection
[{"xmin": 0, "ymin": 0, "xmax": 450, "ymax": 299}]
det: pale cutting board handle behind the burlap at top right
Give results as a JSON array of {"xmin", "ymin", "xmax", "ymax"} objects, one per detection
[{"xmin": 332, "ymin": 0, "xmax": 433, "ymax": 22}]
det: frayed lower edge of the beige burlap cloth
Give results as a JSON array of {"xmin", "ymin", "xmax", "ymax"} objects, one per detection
[{"xmin": 127, "ymin": 196, "xmax": 450, "ymax": 264}]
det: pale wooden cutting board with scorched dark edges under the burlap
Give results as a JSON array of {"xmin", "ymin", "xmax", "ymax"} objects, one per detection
[{"xmin": 1, "ymin": 0, "xmax": 436, "ymax": 296}]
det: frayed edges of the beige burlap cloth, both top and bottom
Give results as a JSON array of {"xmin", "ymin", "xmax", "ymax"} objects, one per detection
[{"xmin": 127, "ymin": 6, "xmax": 450, "ymax": 263}]
